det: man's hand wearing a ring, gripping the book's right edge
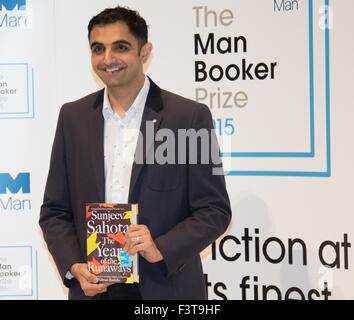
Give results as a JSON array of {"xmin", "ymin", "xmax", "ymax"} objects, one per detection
[{"xmin": 123, "ymin": 224, "xmax": 163, "ymax": 263}]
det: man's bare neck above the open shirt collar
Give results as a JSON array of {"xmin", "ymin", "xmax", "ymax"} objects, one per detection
[{"xmin": 107, "ymin": 75, "xmax": 145, "ymax": 118}]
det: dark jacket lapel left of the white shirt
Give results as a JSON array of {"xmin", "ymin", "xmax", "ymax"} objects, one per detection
[{"xmin": 88, "ymin": 90, "xmax": 105, "ymax": 202}]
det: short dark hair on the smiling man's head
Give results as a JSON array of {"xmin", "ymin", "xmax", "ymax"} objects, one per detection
[{"xmin": 87, "ymin": 6, "xmax": 148, "ymax": 48}]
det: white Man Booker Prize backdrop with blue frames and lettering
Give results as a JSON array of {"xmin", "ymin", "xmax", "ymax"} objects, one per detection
[{"xmin": 0, "ymin": 0, "xmax": 354, "ymax": 300}]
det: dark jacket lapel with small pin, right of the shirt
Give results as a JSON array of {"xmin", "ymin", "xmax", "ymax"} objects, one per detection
[{"xmin": 129, "ymin": 79, "xmax": 163, "ymax": 202}]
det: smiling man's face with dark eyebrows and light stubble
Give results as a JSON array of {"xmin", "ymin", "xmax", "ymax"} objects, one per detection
[{"xmin": 90, "ymin": 22, "xmax": 150, "ymax": 89}]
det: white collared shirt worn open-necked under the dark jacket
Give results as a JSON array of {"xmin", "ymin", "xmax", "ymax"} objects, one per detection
[{"xmin": 102, "ymin": 76, "xmax": 150, "ymax": 203}]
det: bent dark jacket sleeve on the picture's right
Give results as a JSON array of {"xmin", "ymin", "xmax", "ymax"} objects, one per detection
[{"xmin": 155, "ymin": 105, "xmax": 231, "ymax": 276}]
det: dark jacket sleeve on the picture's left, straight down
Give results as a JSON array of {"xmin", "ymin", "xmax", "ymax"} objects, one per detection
[{"xmin": 39, "ymin": 105, "xmax": 84, "ymax": 285}]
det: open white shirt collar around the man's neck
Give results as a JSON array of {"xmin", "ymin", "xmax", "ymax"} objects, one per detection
[{"xmin": 102, "ymin": 75, "xmax": 150, "ymax": 120}]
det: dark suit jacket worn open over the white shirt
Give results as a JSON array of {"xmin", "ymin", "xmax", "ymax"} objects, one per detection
[{"xmin": 39, "ymin": 81, "xmax": 231, "ymax": 299}]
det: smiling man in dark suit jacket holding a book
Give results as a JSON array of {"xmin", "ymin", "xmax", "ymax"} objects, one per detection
[{"xmin": 39, "ymin": 7, "xmax": 231, "ymax": 299}]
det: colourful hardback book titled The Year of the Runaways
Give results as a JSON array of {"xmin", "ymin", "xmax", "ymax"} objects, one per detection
[{"xmin": 86, "ymin": 203, "xmax": 139, "ymax": 284}]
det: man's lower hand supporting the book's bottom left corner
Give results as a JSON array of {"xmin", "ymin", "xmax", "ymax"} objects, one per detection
[{"xmin": 70, "ymin": 263, "xmax": 112, "ymax": 297}]
